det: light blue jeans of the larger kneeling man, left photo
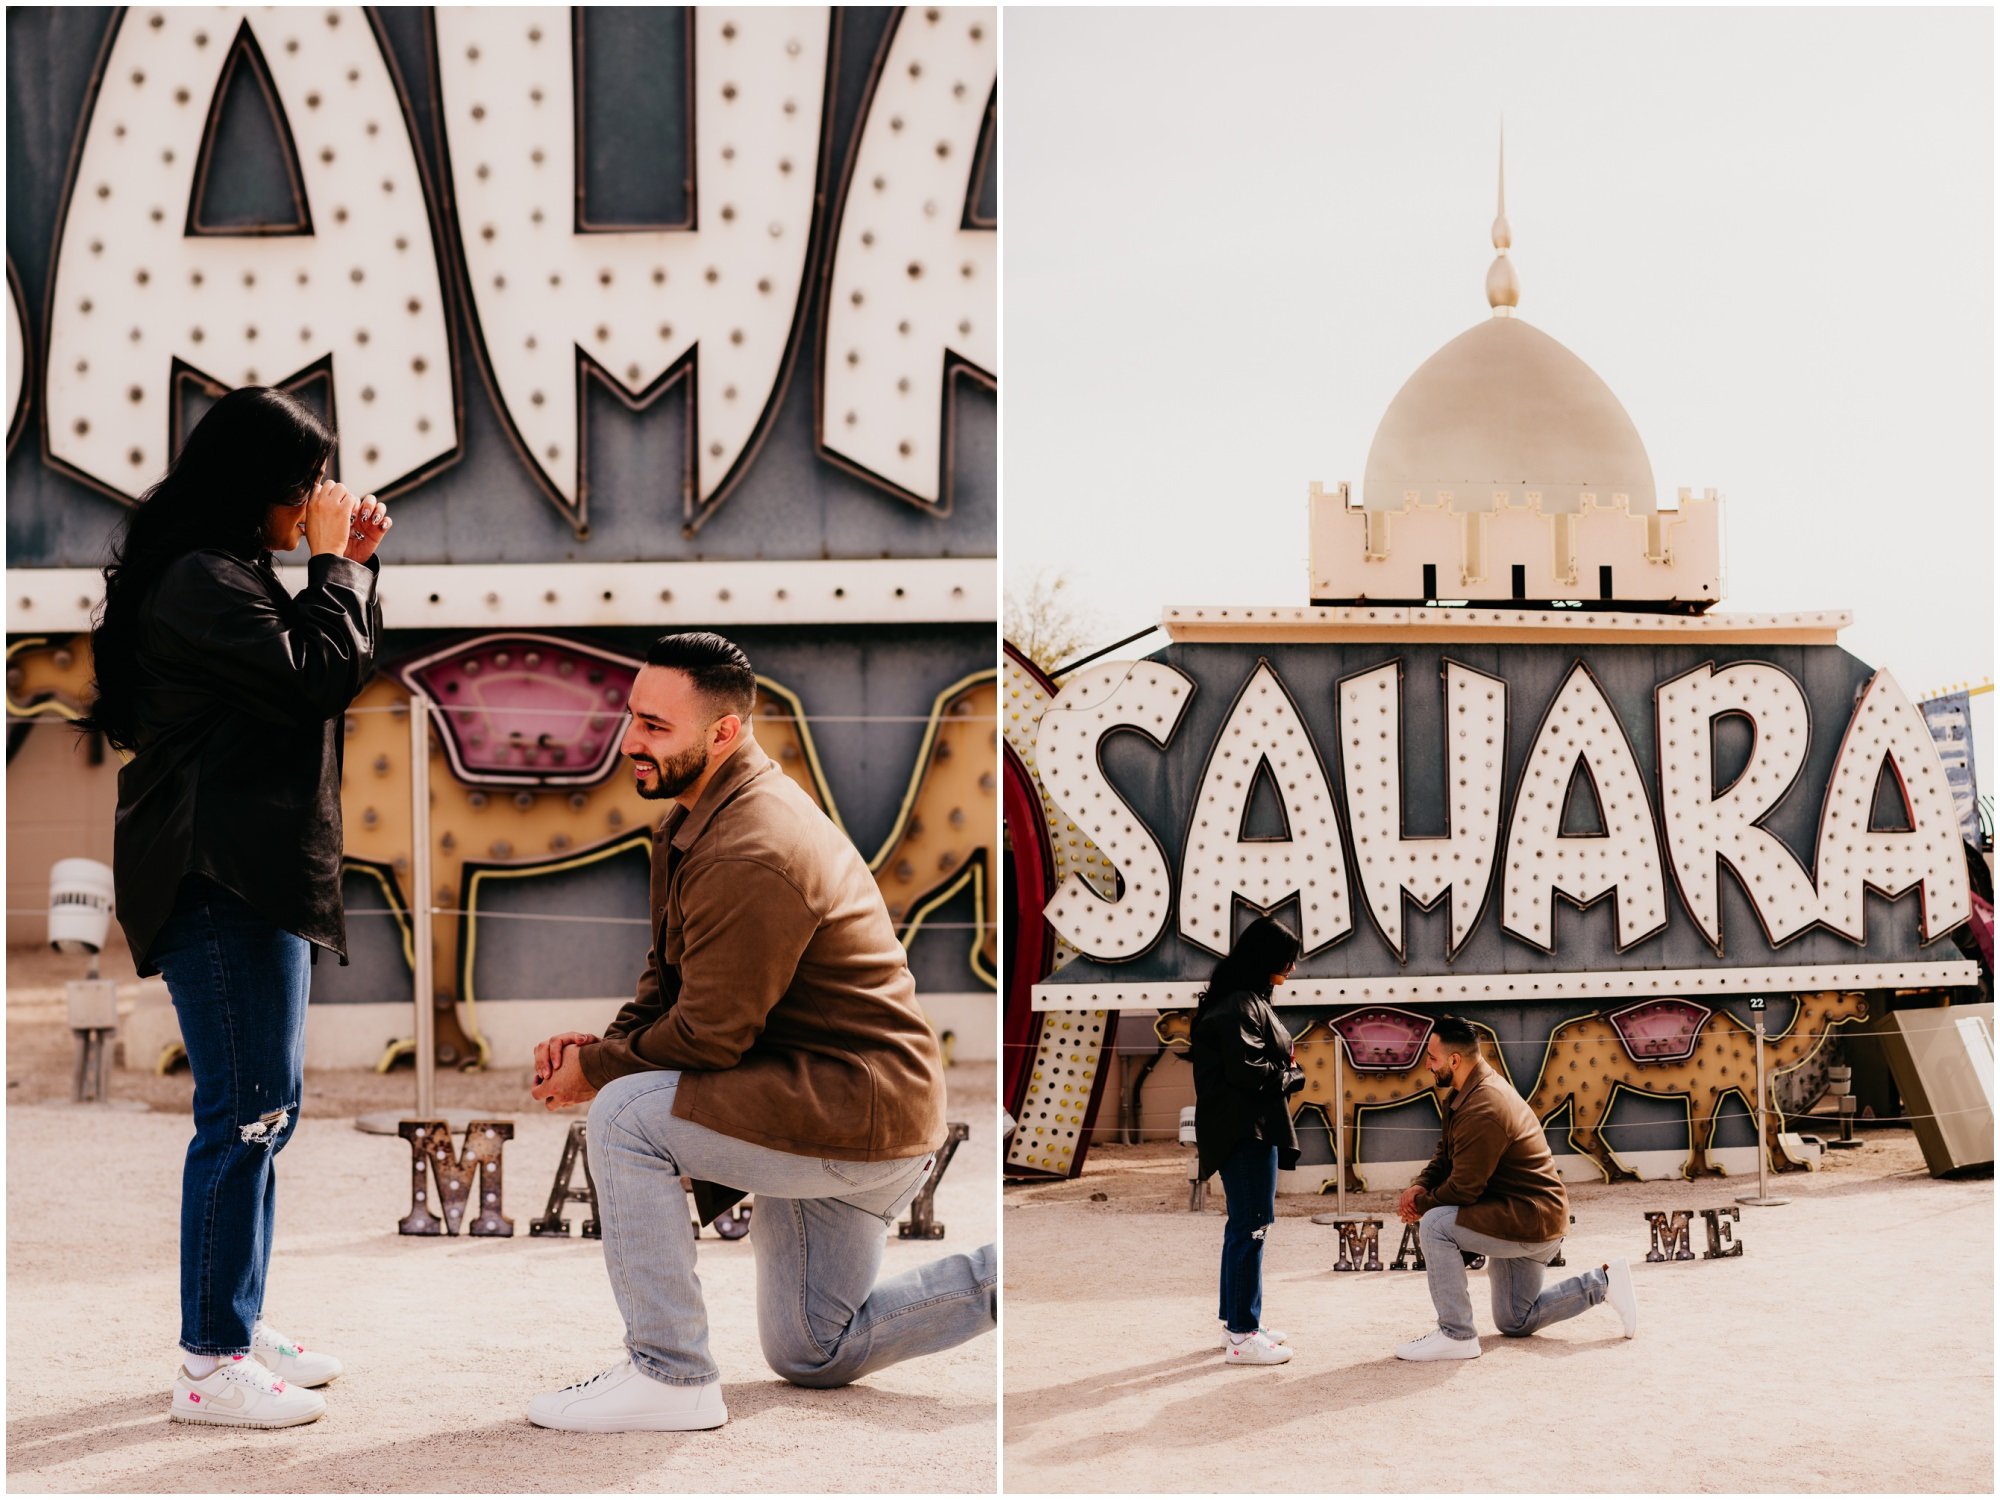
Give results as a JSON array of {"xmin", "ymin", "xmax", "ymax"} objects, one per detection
[{"xmin": 590, "ymin": 1072, "xmax": 1000, "ymax": 1386}]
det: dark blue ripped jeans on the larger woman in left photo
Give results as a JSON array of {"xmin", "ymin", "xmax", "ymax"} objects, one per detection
[{"xmin": 152, "ymin": 876, "xmax": 312, "ymax": 1356}]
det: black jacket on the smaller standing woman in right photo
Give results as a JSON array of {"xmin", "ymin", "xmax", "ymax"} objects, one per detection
[{"xmin": 1188, "ymin": 990, "xmax": 1298, "ymax": 1178}]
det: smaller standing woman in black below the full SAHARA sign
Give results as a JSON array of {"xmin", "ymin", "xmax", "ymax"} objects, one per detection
[{"xmin": 1190, "ymin": 916, "xmax": 1306, "ymax": 1364}]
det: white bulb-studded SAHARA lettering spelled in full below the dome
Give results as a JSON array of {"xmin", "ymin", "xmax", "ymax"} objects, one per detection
[{"xmin": 1036, "ymin": 644, "xmax": 1968, "ymax": 988}]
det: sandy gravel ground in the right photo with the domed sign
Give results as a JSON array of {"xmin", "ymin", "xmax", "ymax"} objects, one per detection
[{"xmin": 1002, "ymin": 1132, "xmax": 1994, "ymax": 1494}]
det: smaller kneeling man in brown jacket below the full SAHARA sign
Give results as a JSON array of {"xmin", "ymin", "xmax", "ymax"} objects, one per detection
[{"xmin": 1396, "ymin": 1016, "xmax": 1638, "ymax": 1360}]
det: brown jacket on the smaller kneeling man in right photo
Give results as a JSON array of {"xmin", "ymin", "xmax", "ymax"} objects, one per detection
[{"xmin": 1416, "ymin": 1060, "xmax": 1570, "ymax": 1244}]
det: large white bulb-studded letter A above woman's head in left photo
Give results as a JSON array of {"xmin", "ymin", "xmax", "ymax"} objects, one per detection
[{"xmin": 46, "ymin": 6, "xmax": 458, "ymax": 498}]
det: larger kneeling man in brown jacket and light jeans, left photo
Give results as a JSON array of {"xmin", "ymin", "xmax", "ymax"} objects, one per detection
[{"xmin": 528, "ymin": 634, "xmax": 998, "ymax": 1432}]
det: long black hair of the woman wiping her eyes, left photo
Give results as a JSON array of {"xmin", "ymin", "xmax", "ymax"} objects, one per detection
[{"xmin": 76, "ymin": 386, "xmax": 334, "ymax": 750}]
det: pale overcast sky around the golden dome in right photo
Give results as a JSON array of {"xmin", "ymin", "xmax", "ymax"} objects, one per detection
[{"xmin": 1000, "ymin": 8, "xmax": 1994, "ymax": 792}]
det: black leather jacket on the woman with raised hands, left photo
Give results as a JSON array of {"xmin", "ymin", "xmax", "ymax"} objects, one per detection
[{"xmin": 112, "ymin": 552, "xmax": 382, "ymax": 974}]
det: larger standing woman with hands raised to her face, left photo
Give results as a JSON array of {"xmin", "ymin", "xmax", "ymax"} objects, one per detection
[{"xmin": 82, "ymin": 386, "xmax": 390, "ymax": 1428}]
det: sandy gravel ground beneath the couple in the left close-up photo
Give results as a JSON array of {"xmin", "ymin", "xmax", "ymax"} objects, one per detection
[{"xmin": 6, "ymin": 994, "xmax": 998, "ymax": 1494}]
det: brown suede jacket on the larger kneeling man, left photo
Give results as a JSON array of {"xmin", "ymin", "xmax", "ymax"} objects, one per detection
[{"xmin": 578, "ymin": 736, "xmax": 944, "ymax": 1162}]
